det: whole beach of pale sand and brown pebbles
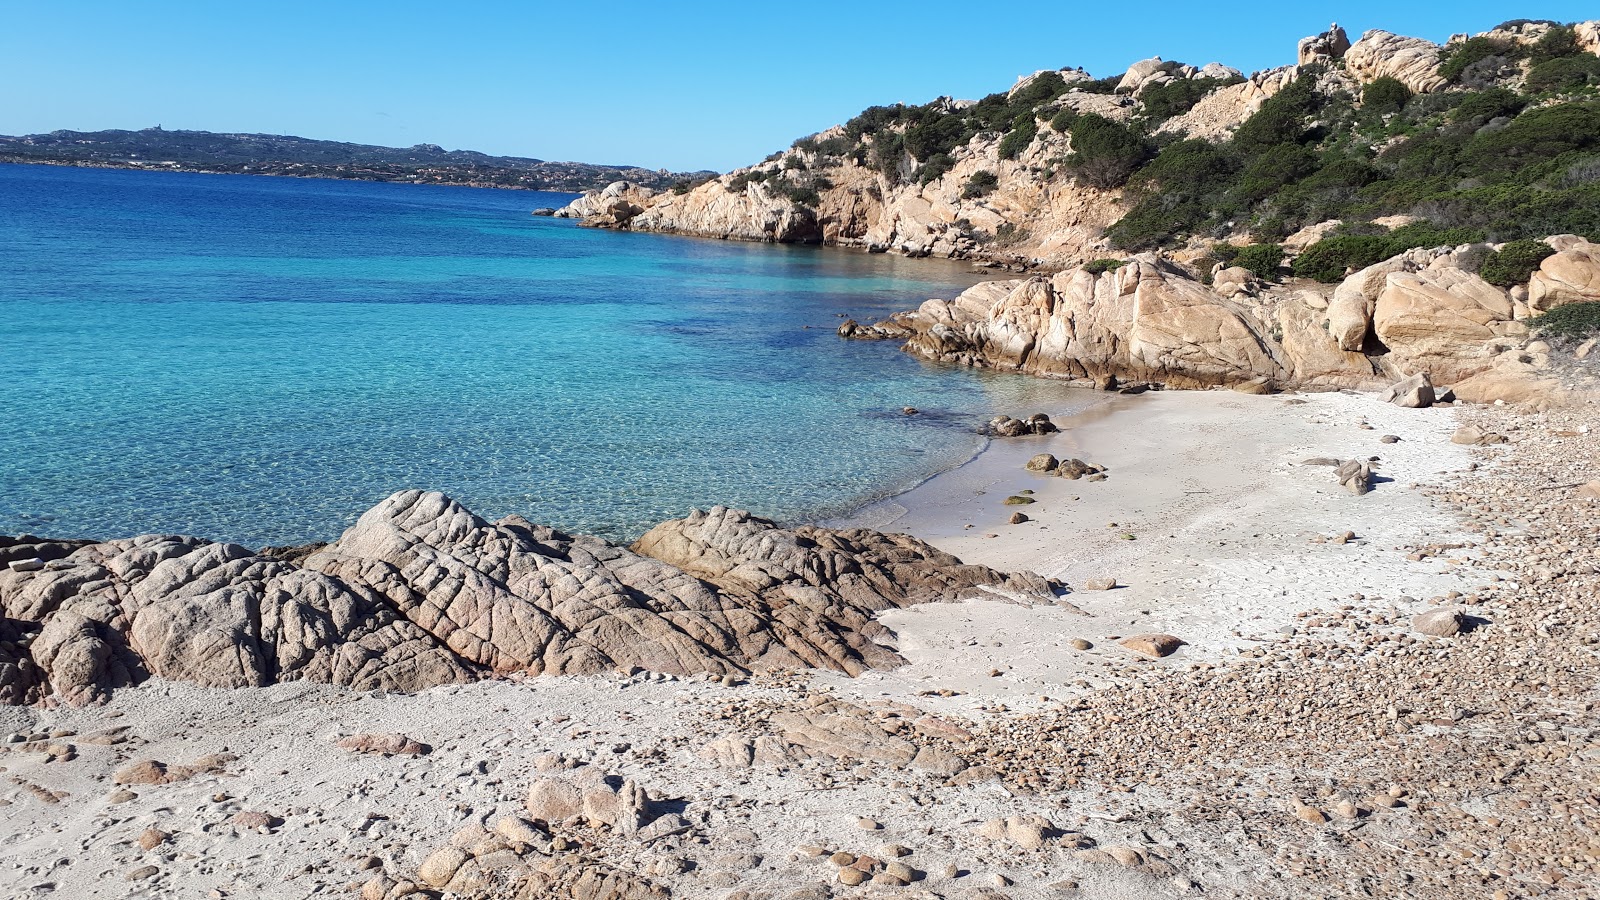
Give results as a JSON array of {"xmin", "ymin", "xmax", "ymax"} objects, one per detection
[{"xmin": 0, "ymin": 381, "xmax": 1600, "ymax": 900}]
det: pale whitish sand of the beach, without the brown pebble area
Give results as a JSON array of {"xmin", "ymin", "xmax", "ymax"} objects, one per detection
[{"xmin": 0, "ymin": 392, "xmax": 1497, "ymax": 898}]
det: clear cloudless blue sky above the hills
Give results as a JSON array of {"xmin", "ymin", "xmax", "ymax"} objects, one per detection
[{"xmin": 0, "ymin": 0, "xmax": 1600, "ymax": 170}]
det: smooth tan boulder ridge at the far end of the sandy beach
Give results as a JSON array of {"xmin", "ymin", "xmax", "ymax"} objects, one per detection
[{"xmin": 851, "ymin": 239, "xmax": 1580, "ymax": 393}]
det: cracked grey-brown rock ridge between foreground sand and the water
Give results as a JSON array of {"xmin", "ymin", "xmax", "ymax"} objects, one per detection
[{"xmin": 0, "ymin": 490, "xmax": 1054, "ymax": 705}]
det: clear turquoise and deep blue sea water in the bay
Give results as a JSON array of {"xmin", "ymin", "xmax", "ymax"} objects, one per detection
[{"xmin": 0, "ymin": 165, "xmax": 1082, "ymax": 546}]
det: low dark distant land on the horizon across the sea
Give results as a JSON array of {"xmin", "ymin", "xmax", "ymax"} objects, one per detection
[{"xmin": 0, "ymin": 125, "xmax": 715, "ymax": 192}]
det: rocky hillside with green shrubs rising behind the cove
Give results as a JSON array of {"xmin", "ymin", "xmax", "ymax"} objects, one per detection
[{"xmin": 585, "ymin": 19, "xmax": 1600, "ymax": 272}]
